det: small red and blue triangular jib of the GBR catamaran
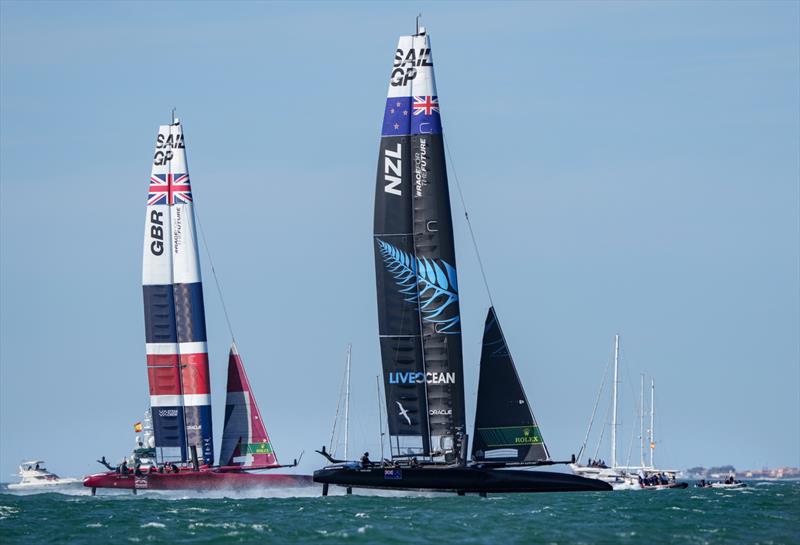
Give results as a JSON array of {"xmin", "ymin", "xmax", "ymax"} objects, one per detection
[{"xmin": 219, "ymin": 344, "xmax": 278, "ymax": 468}]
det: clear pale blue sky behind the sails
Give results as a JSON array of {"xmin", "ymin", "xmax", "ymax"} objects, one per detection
[{"xmin": 0, "ymin": 1, "xmax": 800, "ymax": 481}]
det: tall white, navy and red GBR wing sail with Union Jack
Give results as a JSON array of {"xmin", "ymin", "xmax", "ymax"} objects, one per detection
[{"xmin": 142, "ymin": 121, "xmax": 214, "ymax": 464}]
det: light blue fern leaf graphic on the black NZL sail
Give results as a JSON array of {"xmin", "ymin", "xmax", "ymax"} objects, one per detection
[{"xmin": 375, "ymin": 239, "xmax": 461, "ymax": 334}]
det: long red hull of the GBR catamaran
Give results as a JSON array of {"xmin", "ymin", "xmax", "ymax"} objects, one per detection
[{"xmin": 83, "ymin": 469, "xmax": 313, "ymax": 490}]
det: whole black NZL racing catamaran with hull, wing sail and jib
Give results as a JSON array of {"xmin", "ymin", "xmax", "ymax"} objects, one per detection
[{"xmin": 314, "ymin": 27, "xmax": 611, "ymax": 495}]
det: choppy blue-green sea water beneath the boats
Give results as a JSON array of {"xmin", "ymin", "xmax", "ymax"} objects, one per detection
[{"xmin": 0, "ymin": 482, "xmax": 800, "ymax": 545}]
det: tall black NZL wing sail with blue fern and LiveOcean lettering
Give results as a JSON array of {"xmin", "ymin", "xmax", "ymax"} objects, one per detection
[{"xmin": 374, "ymin": 26, "xmax": 466, "ymax": 461}]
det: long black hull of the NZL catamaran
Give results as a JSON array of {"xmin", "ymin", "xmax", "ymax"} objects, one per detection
[{"xmin": 314, "ymin": 466, "xmax": 611, "ymax": 494}]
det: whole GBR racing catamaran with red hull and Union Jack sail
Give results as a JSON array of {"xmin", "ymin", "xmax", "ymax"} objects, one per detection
[{"xmin": 83, "ymin": 119, "xmax": 312, "ymax": 493}]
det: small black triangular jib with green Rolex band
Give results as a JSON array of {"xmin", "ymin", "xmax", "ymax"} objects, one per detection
[{"xmin": 472, "ymin": 307, "xmax": 550, "ymax": 462}]
